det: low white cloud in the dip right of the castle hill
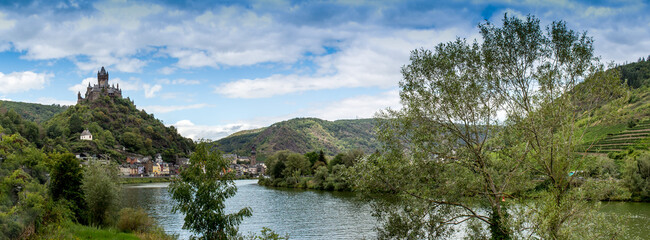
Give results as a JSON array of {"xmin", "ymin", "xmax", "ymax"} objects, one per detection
[{"xmin": 172, "ymin": 120, "xmax": 259, "ymax": 140}]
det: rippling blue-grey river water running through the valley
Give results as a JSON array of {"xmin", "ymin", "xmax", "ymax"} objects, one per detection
[{"xmin": 123, "ymin": 180, "xmax": 650, "ymax": 239}]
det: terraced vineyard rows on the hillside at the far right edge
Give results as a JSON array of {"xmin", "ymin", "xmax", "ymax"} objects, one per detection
[{"xmin": 586, "ymin": 120, "xmax": 650, "ymax": 153}]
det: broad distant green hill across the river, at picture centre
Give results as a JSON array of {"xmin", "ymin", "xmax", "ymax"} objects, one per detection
[{"xmin": 216, "ymin": 118, "xmax": 378, "ymax": 158}]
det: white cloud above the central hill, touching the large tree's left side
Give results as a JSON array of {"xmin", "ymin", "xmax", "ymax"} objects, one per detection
[{"xmin": 308, "ymin": 89, "xmax": 402, "ymax": 121}]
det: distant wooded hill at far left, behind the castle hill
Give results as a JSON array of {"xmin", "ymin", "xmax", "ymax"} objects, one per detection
[{"xmin": 0, "ymin": 100, "xmax": 68, "ymax": 122}]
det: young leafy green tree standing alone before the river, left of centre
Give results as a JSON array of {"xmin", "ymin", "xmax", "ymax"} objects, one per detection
[{"xmin": 168, "ymin": 142, "xmax": 251, "ymax": 239}]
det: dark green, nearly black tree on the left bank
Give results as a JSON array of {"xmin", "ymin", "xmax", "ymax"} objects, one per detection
[{"xmin": 49, "ymin": 153, "xmax": 86, "ymax": 223}]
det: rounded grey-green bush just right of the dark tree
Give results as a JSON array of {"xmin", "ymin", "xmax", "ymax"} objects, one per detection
[{"xmin": 81, "ymin": 161, "xmax": 121, "ymax": 226}]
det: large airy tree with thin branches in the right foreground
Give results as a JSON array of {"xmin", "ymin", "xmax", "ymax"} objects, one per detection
[{"xmin": 361, "ymin": 16, "xmax": 620, "ymax": 239}]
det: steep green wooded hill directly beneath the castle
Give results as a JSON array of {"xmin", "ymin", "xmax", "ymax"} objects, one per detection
[{"xmin": 42, "ymin": 97, "xmax": 194, "ymax": 161}]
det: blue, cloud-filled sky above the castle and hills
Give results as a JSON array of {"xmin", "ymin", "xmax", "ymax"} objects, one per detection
[{"xmin": 0, "ymin": 0, "xmax": 650, "ymax": 140}]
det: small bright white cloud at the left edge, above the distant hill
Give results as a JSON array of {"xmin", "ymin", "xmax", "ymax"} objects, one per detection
[{"xmin": 0, "ymin": 71, "xmax": 54, "ymax": 94}]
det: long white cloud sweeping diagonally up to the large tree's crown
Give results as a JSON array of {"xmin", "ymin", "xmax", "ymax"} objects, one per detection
[{"xmin": 215, "ymin": 29, "xmax": 467, "ymax": 98}]
